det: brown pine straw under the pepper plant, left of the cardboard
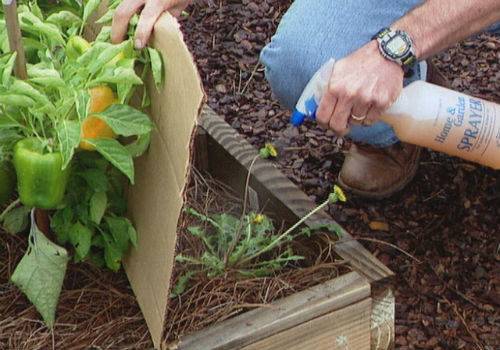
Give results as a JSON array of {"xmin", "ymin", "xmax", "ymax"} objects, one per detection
[{"xmin": 0, "ymin": 232, "xmax": 151, "ymax": 350}]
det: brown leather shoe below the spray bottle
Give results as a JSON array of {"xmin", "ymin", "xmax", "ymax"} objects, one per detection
[{"xmin": 338, "ymin": 142, "xmax": 421, "ymax": 199}]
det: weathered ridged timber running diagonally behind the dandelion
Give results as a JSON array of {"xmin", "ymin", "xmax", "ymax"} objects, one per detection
[{"xmin": 200, "ymin": 106, "xmax": 393, "ymax": 281}]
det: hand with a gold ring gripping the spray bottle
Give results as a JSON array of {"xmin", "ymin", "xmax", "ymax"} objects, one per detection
[{"xmin": 316, "ymin": 41, "xmax": 404, "ymax": 136}]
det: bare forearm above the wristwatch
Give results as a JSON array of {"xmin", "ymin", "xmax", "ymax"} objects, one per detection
[{"xmin": 391, "ymin": 0, "xmax": 500, "ymax": 60}]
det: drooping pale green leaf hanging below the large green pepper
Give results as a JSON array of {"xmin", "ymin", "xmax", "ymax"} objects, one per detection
[{"xmin": 11, "ymin": 212, "xmax": 69, "ymax": 328}]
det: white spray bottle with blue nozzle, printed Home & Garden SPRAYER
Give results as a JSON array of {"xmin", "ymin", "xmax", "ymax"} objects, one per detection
[{"xmin": 291, "ymin": 59, "xmax": 500, "ymax": 170}]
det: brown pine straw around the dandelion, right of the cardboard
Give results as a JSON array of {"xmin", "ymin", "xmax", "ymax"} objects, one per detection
[{"xmin": 166, "ymin": 172, "xmax": 348, "ymax": 341}]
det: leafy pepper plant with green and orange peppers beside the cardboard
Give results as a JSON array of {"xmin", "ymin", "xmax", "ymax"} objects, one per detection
[{"xmin": 0, "ymin": 0, "xmax": 163, "ymax": 326}]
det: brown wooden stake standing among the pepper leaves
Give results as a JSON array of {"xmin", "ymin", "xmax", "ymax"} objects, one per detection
[{"xmin": 2, "ymin": 0, "xmax": 28, "ymax": 80}]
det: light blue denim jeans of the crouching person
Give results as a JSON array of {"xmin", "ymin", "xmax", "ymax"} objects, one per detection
[{"xmin": 261, "ymin": 0, "xmax": 500, "ymax": 147}]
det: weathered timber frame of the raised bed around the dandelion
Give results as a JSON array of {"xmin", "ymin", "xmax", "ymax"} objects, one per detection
[{"xmin": 164, "ymin": 106, "xmax": 394, "ymax": 350}]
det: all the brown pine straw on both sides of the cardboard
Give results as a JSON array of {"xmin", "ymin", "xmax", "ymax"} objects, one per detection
[{"xmin": 0, "ymin": 172, "xmax": 349, "ymax": 350}]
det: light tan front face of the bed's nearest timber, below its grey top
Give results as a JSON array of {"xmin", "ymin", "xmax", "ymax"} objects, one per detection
[{"xmin": 242, "ymin": 298, "xmax": 371, "ymax": 350}]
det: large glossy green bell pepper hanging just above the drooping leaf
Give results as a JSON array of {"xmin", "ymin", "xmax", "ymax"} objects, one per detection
[{"xmin": 14, "ymin": 138, "xmax": 69, "ymax": 209}]
